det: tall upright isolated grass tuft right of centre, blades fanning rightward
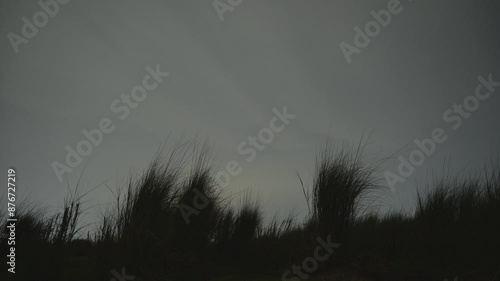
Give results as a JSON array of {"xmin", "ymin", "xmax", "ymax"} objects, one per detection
[{"xmin": 311, "ymin": 137, "xmax": 377, "ymax": 241}]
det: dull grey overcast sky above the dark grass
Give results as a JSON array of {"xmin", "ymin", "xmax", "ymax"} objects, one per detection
[{"xmin": 0, "ymin": 0, "xmax": 500, "ymax": 223}]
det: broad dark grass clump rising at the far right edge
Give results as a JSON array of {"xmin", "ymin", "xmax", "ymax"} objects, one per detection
[{"xmin": 415, "ymin": 161, "xmax": 500, "ymax": 265}]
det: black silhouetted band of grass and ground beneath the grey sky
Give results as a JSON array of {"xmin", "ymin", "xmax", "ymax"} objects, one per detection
[{"xmin": 0, "ymin": 139, "xmax": 500, "ymax": 281}]
